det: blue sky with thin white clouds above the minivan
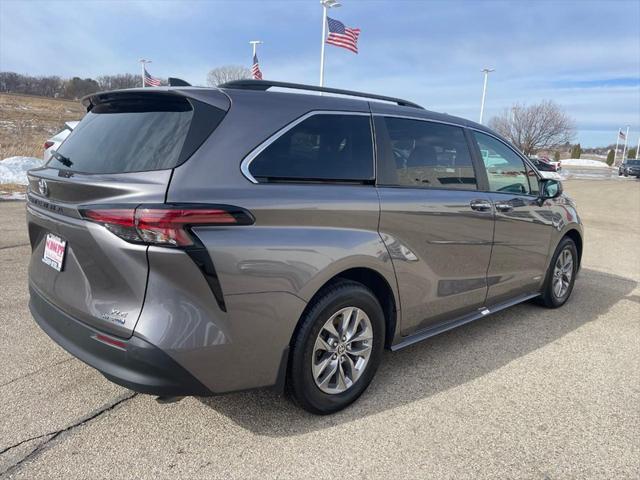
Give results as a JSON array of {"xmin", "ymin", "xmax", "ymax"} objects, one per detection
[{"xmin": 0, "ymin": 0, "xmax": 640, "ymax": 146}]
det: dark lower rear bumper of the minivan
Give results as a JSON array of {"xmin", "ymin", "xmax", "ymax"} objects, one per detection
[{"xmin": 29, "ymin": 286, "xmax": 212, "ymax": 396}]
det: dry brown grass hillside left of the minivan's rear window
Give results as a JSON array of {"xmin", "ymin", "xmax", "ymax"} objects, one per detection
[{"xmin": 0, "ymin": 93, "xmax": 85, "ymax": 159}]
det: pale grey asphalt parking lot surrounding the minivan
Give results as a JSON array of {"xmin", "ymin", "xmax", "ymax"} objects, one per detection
[{"xmin": 0, "ymin": 179, "xmax": 640, "ymax": 479}]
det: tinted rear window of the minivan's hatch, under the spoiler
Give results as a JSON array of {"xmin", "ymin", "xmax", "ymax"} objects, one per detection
[{"xmin": 47, "ymin": 96, "xmax": 193, "ymax": 173}]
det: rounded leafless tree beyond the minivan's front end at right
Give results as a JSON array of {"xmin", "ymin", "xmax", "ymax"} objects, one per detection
[{"xmin": 489, "ymin": 100, "xmax": 575, "ymax": 155}]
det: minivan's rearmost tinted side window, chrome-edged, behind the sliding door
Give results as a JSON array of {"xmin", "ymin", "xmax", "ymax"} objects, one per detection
[{"xmin": 249, "ymin": 114, "xmax": 374, "ymax": 181}]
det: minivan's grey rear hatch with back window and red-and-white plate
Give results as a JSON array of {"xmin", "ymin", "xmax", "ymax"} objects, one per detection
[{"xmin": 27, "ymin": 89, "xmax": 228, "ymax": 338}]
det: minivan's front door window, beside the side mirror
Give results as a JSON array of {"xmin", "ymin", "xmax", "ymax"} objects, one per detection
[{"xmin": 473, "ymin": 132, "xmax": 533, "ymax": 194}]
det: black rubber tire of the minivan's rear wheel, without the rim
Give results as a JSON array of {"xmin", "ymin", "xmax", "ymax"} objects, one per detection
[{"xmin": 287, "ymin": 280, "xmax": 385, "ymax": 415}]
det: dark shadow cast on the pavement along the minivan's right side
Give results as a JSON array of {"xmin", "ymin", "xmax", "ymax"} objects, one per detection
[{"xmin": 200, "ymin": 269, "xmax": 638, "ymax": 437}]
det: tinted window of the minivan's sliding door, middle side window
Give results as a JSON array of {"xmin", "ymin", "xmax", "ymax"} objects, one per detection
[{"xmin": 380, "ymin": 117, "xmax": 476, "ymax": 190}]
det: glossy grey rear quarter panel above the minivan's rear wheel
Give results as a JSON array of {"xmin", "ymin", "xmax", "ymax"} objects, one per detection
[{"xmin": 194, "ymin": 184, "xmax": 398, "ymax": 305}]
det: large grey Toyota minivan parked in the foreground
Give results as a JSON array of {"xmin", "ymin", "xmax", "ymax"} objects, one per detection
[{"xmin": 27, "ymin": 80, "xmax": 583, "ymax": 414}]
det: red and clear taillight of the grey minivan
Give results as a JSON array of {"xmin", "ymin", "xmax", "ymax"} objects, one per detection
[{"xmin": 80, "ymin": 205, "xmax": 253, "ymax": 247}]
